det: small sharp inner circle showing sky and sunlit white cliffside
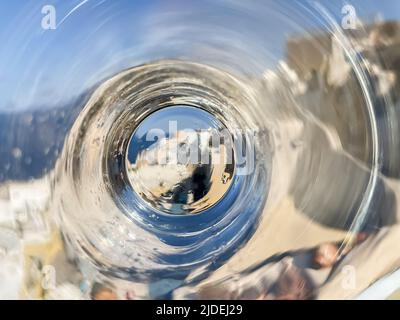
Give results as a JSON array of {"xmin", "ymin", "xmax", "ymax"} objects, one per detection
[{"xmin": 126, "ymin": 106, "xmax": 235, "ymax": 214}]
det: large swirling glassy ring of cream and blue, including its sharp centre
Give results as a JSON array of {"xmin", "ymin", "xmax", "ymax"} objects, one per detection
[{"xmin": 57, "ymin": 61, "xmax": 272, "ymax": 283}]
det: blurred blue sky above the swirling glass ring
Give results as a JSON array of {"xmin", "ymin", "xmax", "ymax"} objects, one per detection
[{"xmin": 0, "ymin": 0, "xmax": 400, "ymax": 111}]
